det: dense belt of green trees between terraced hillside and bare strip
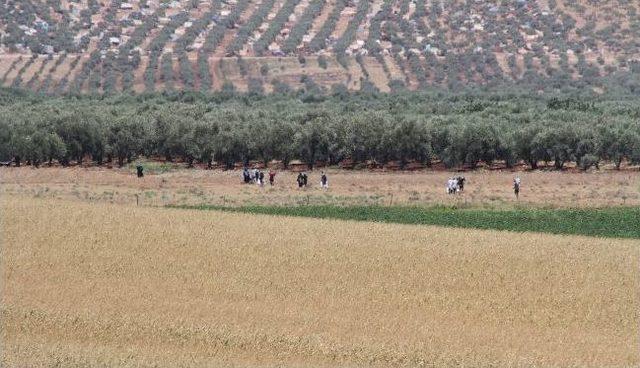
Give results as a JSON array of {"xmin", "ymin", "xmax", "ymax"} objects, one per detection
[{"xmin": 0, "ymin": 90, "xmax": 640, "ymax": 170}]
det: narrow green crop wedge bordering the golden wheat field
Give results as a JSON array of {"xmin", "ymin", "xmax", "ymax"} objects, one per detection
[{"xmin": 172, "ymin": 205, "xmax": 640, "ymax": 239}]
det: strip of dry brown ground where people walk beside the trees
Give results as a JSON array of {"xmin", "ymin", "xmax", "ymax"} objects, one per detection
[{"xmin": 0, "ymin": 168, "xmax": 640, "ymax": 208}]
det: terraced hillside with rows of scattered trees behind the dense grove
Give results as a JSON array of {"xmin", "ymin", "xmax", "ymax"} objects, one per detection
[{"xmin": 0, "ymin": 0, "xmax": 640, "ymax": 93}]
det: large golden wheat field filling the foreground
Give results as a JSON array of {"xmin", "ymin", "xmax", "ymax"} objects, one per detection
[{"xmin": 0, "ymin": 195, "xmax": 640, "ymax": 367}]
